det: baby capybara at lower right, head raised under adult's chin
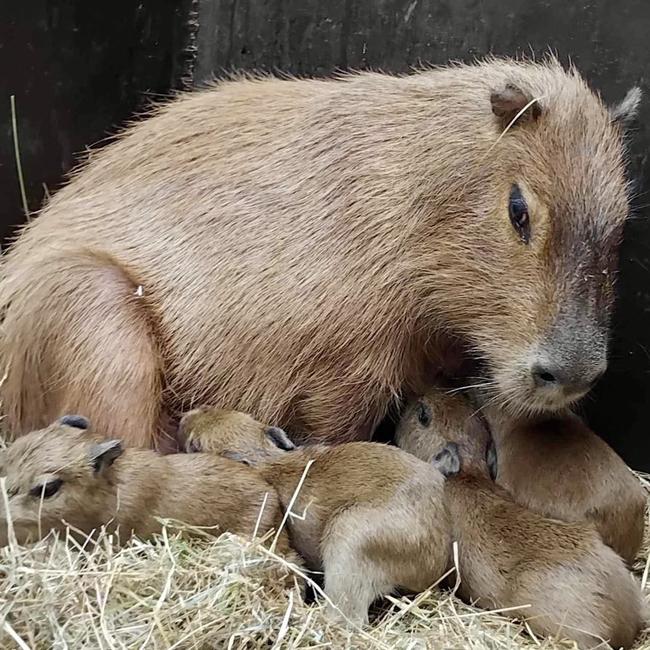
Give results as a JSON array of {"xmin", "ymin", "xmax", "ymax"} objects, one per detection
[{"xmin": 398, "ymin": 393, "xmax": 641, "ymax": 648}]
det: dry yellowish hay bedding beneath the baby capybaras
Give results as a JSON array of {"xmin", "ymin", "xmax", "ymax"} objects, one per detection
[{"xmin": 0, "ymin": 477, "xmax": 650, "ymax": 650}]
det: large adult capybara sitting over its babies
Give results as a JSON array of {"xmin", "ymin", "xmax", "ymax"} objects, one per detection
[{"xmin": 0, "ymin": 60, "xmax": 639, "ymax": 446}]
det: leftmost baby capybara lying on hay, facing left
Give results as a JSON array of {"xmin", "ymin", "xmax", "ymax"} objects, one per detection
[{"xmin": 0, "ymin": 416, "xmax": 289, "ymax": 552}]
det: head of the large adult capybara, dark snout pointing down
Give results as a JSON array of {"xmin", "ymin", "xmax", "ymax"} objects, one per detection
[{"xmin": 418, "ymin": 62, "xmax": 640, "ymax": 413}]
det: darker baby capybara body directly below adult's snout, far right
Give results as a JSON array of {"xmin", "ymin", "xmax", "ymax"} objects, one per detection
[{"xmin": 482, "ymin": 405, "xmax": 647, "ymax": 562}]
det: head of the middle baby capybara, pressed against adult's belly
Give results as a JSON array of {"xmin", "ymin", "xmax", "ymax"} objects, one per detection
[{"xmin": 178, "ymin": 406, "xmax": 295, "ymax": 465}]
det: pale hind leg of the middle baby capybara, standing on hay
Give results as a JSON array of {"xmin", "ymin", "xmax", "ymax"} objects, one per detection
[{"xmin": 321, "ymin": 509, "xmax": 395, "ymax": 625}]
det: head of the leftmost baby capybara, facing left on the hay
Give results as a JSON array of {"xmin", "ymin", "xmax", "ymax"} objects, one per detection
[{"xmin": 0, "ymin": 415, "xmax": 123, "ymax": 546}]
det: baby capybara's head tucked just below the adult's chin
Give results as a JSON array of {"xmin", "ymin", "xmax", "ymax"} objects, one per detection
[{"xmin": 395, "ymin": 388, "xmax": 497, "ymax": 480}]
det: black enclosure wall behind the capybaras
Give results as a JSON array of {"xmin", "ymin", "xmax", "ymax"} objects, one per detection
[{"xmin": 0, "ymin": 0, "xmax": 650, "ymax": 470}]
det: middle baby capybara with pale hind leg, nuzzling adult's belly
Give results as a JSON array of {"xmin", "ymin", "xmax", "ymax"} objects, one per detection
[{"xmin": 181, "ymin": 408, "xmax": 450, "ymax": 623}]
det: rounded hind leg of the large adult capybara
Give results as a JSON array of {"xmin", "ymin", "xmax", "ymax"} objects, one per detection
[{"xmin": 0, "ymin": 252, "xmax": 162, "ymax": 447}]
